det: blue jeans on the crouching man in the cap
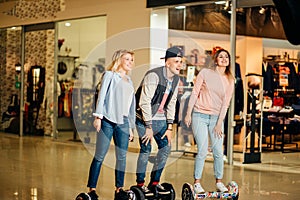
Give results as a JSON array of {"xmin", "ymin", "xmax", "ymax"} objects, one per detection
[{"xmin": 136, "ymin": 119, "xmax": 171, "ymax": 184}]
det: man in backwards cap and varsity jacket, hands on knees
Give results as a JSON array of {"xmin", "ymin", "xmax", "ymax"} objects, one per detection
[{"xmin": 135, "ymin": 47, "xmax": 182, "ymax": 197}]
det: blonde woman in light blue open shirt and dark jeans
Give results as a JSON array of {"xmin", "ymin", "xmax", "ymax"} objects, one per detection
[{"xmin": 87, "ymin": 50, "xmax": 135, "ymax": 200}]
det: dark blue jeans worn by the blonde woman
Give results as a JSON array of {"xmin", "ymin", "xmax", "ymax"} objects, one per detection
[{"xmin": 87, "ymin": 117, "xmax": 129, "ymax": 188}]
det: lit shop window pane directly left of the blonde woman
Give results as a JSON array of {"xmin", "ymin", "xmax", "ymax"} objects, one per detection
[{"xmin": 57, "ymin": 16, "xmax": 106, "ymax": 141}]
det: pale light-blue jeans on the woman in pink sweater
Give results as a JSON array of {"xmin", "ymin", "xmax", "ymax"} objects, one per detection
[{"xmin": 192, "ymin": 112, "xmax": 224, "ymax": 179}]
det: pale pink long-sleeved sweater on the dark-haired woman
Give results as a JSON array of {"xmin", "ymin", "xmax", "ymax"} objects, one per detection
[{"xmin": 189, "ymin": 68, "xmax": 234, "ymax": 120}]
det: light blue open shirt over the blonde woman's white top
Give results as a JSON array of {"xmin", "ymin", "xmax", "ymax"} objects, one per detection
[{"xmin": 93, "ymin": 71, "xmax": 135, "ymax": 128}]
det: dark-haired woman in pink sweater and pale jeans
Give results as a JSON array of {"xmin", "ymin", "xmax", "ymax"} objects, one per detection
[{"xmin": 184, "ymin": 49, "xmax": 234, "ymax": 193}]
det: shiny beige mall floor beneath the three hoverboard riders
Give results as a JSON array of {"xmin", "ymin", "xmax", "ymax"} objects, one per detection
[{"xmin": 0, "ymin": 133, "xmax": 300, "ymax": 200}]
